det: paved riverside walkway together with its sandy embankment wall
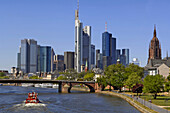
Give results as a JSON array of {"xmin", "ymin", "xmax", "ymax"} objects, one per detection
[{"xmin": 99, "ymin": 91, "xmax": 170, "ymax": 113}]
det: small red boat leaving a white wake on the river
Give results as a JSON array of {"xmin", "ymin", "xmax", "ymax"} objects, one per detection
[{"xmin": 25, "ymin": 92, "xmax": 40, "ymax": 104}]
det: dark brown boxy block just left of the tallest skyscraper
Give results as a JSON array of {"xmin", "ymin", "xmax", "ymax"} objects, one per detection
[{"xmin": 64, "ymin": 51, "xmax": 74, "ymax": 70}]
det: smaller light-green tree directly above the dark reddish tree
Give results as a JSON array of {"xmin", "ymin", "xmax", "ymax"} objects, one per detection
[{"xmin": 125, "ymin": 72, "xmax": 141, "ymax": 91}]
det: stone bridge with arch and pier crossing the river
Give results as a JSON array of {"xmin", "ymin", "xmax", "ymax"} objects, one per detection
[{"xmin": 0, "ymin": 79, "xmax": 99, "ymax": 93}]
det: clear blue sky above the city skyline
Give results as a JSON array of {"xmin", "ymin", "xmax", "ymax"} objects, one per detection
[{"xmin": 0, "ymin": 0, "xmax": 170, "ymax": 70}]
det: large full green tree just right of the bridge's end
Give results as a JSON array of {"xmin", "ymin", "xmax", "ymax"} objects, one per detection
[{"xmin": 104, "ymin": 64, "xmax": 127, "ymax": 91}]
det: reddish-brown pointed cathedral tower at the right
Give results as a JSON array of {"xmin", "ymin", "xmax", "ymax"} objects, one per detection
[{"xmin": 148, "ymin": 26, "xmax": 162, "ymax": 63}]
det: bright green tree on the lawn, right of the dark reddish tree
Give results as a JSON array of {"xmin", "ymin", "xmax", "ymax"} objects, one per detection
[{"xmin": 143, "ymin": 75, "xmax": 165, "ymax": 99}]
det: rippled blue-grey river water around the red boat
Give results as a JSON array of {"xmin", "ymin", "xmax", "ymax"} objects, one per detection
[{"xmin": 0, "ymin": 86, "xmax": 140, "ymax": 113}]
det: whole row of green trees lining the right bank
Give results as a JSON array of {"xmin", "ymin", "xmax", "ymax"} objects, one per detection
[{"xmin": 97, "ymin": 64, "xmax": 170, "ymax": 98}]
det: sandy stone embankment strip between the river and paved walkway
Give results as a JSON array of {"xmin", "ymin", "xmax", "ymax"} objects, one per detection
[{"xmin": 97, "ymin": 91, "xmax": 158, "ymax": 113}]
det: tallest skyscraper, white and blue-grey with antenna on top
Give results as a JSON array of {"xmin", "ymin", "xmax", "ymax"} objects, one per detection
[{"xmin": 74, "ymin": 0, "xmax": 94, "ymax": 72}]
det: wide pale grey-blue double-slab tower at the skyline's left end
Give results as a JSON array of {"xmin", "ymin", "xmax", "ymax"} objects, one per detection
[{"xmin": 21, "ymin": 39, "xmax": 37, "ymax": 73}]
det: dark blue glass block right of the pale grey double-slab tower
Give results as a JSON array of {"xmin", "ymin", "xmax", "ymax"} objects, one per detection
[{"xmin": 40, "ymin": 46, "xmax": 51, "ymax": 73}]
